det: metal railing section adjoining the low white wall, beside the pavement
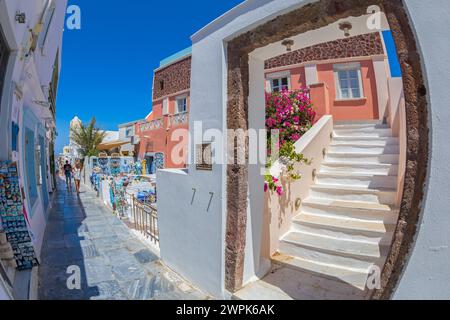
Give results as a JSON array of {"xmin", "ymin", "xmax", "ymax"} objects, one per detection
[{"xmin": 132, "ymin": 196, "xmax": 159, "ymax": 245}]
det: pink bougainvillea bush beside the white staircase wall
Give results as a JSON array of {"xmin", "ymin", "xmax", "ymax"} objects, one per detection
[{"xmin": 264, "ymin": 88, "xmax": 316, "ymax": 196}]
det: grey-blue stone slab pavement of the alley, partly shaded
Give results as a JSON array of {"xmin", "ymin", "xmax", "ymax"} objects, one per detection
[{"xmin": 39, "ymin": 182, "xmax": 208, "ymax": 300}]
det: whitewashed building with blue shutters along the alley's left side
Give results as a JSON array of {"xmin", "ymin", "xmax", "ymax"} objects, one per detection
[{"xmin": 0, "ymin": 0, "xmax": 67, "ymax": 299}]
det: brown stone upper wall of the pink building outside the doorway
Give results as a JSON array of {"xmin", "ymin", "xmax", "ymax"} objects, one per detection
[{"xmin": 153, "ymin": 56, "xmax": 192, "ymax": 101}]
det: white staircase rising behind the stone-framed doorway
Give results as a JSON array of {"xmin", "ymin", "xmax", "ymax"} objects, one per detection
[{"xmin": 272, "ymin": 122, "xmax": 399, "ymax": 291}]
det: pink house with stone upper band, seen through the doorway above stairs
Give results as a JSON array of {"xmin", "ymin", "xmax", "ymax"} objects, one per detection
[{"xmin": 265, "ymin": 32, "xmax": 389, "ymax": 121}]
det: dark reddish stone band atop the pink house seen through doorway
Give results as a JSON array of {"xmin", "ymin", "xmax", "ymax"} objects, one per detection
[{"xmin": 265, "ymin": 32, "xmax": 384, "ymax": 69}]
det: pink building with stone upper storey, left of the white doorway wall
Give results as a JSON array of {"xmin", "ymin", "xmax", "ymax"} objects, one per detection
[{"xmin": 136, "ymin": 54, "xmax": 191, "ymax": 173}]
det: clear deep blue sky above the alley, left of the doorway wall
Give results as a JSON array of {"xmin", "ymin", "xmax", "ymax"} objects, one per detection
[{"xmin": 56, "ymin": 0, "xmax": 246, "ymax": 153}]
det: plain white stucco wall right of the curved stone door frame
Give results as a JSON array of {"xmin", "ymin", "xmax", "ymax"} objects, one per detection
[{"xmin": 394, "ymin": 0, "xmax": 450, "ymax": 299}]
